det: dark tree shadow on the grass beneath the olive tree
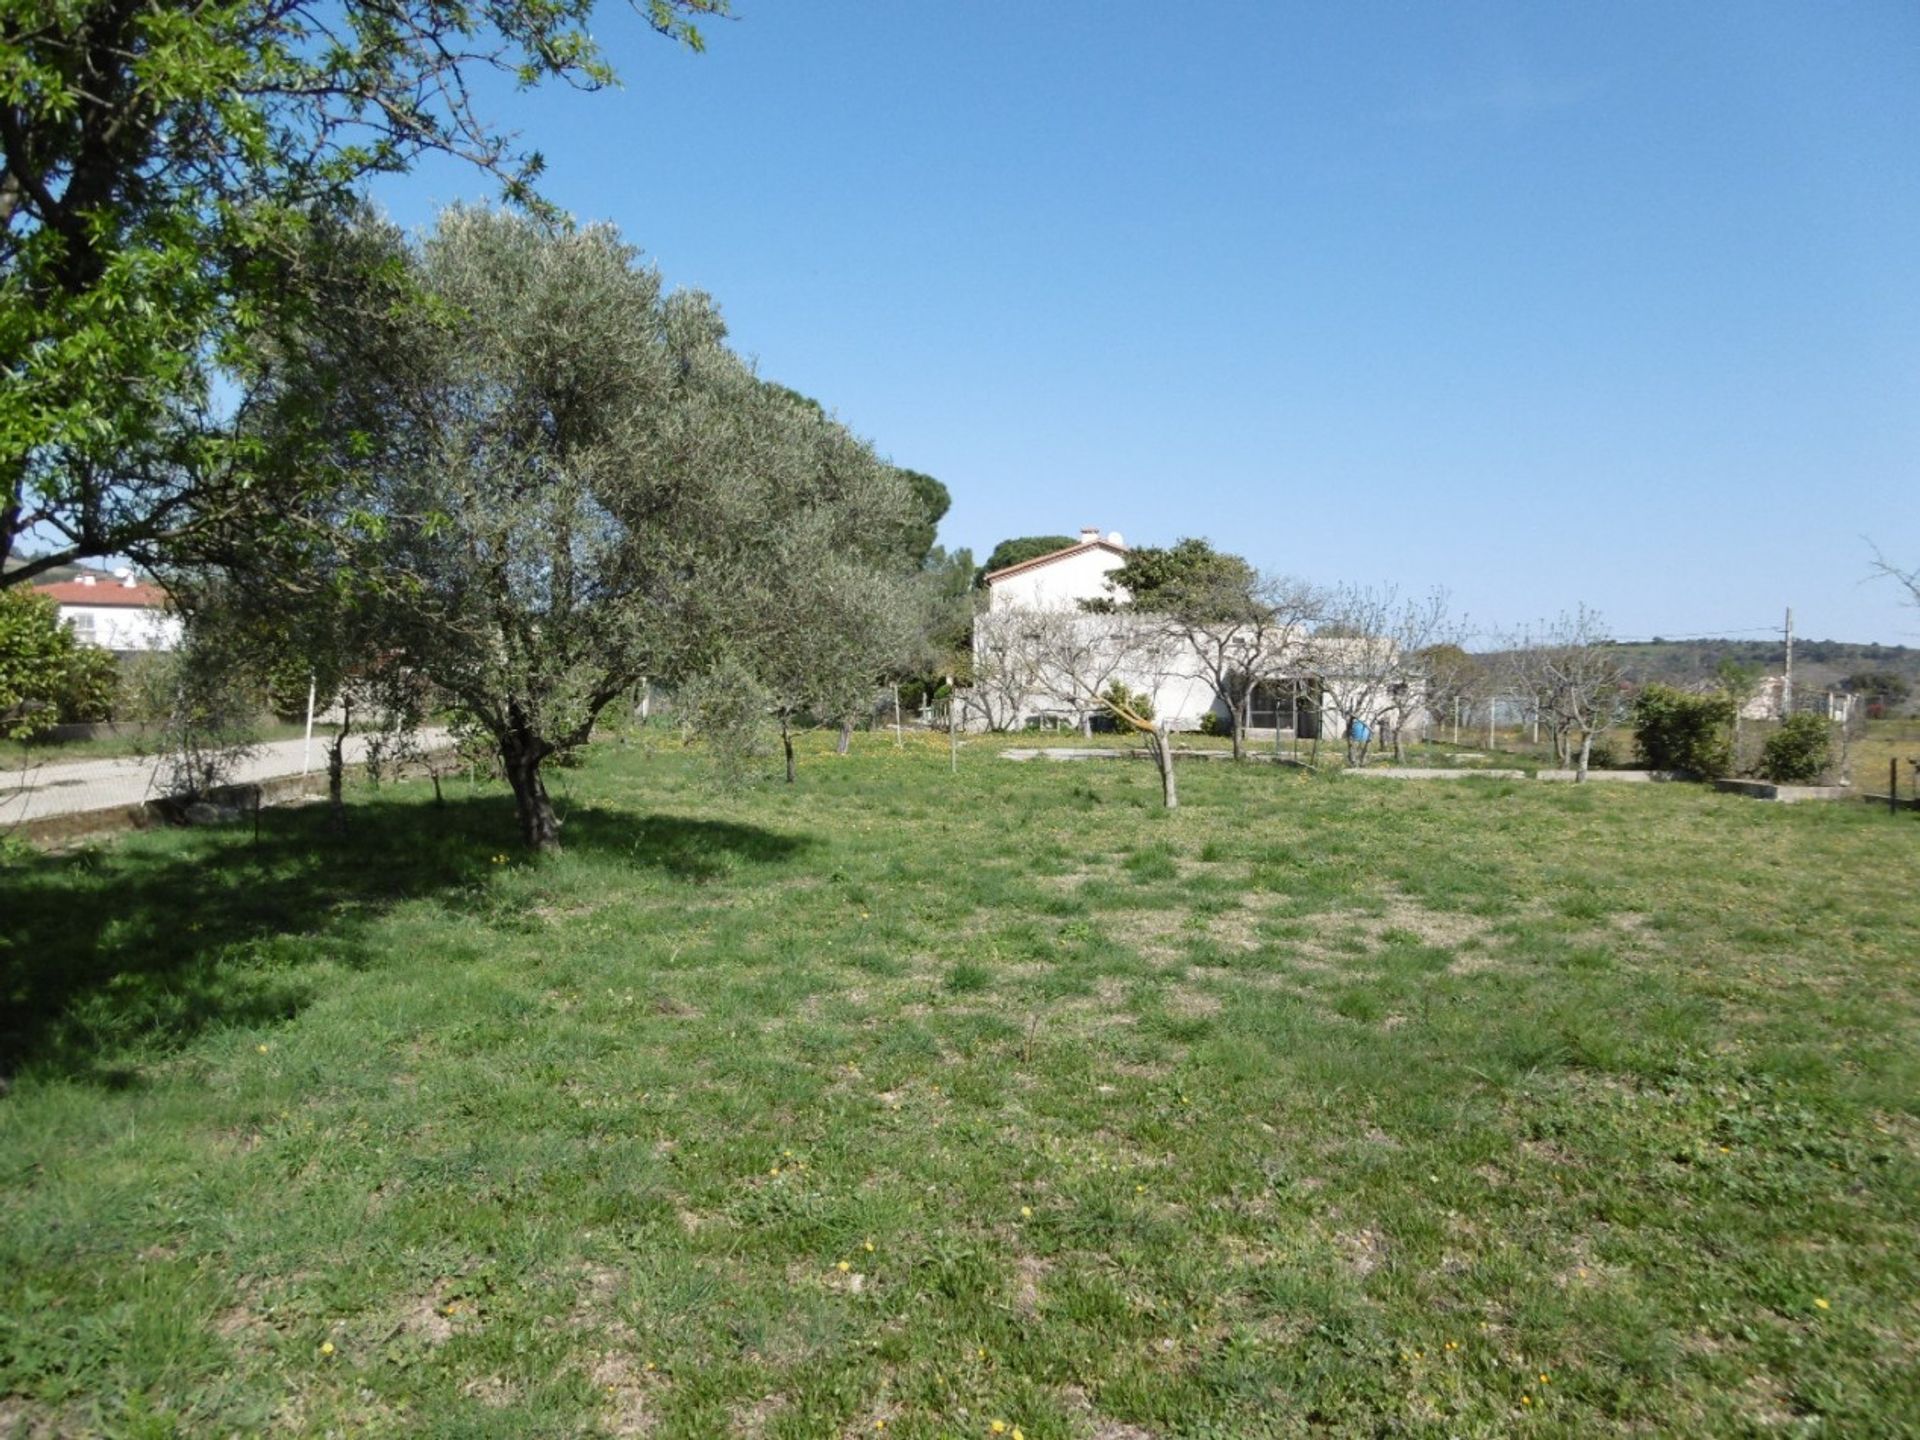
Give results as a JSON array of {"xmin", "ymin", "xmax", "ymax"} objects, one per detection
[{"xmin": 0, "ymin": 795, "xmax": 810, "ymax": 1087}]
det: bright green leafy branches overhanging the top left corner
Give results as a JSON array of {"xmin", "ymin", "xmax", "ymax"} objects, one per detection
[{"xmin": 0, "ymin": 0, "xmax": 726, "ymax": 586}]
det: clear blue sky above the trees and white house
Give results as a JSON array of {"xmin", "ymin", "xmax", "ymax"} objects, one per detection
[{"xmin": 378, "ymin": 0, "xmax": 1920, "ymax": 643}]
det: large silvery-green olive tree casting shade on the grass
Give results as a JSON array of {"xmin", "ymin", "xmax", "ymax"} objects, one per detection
[{"xmin": 259, "ymin": 209, "xmax": 908, "ymax": 849}]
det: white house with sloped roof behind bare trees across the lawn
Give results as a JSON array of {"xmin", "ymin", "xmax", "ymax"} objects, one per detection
[{"xmin": 972, "ymin": 528, "xmax": 1427, "ymax": 739}]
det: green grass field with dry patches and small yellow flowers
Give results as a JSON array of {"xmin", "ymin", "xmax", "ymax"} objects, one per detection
[{"xmin": 0, "ymin": 735, "xmax": 1920, "ymax": 1440}]
